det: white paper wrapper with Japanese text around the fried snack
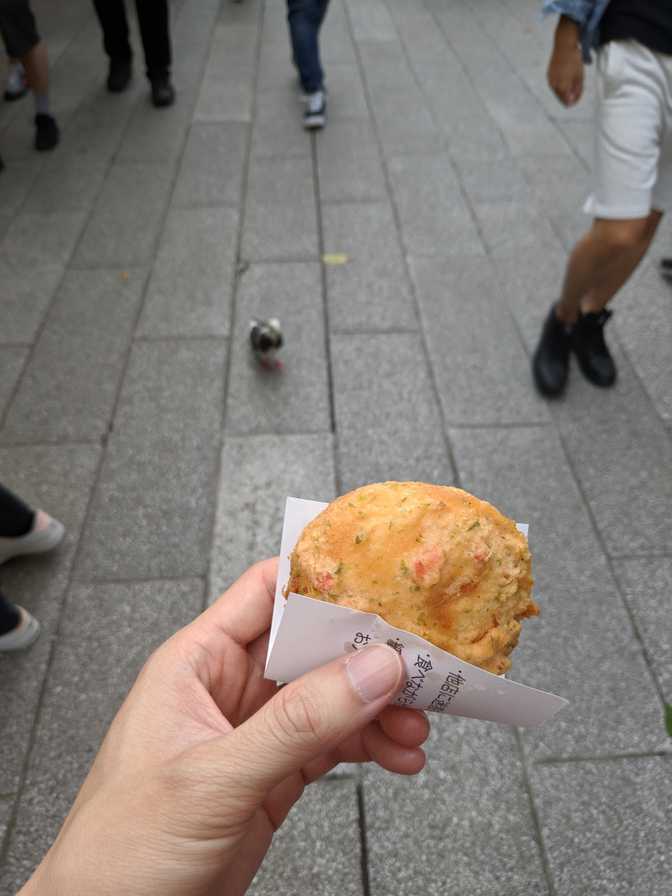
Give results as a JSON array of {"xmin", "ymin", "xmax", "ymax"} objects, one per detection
[{"xmin": 265, "ymin": 498, "xmax": 568, "ymax": 727}]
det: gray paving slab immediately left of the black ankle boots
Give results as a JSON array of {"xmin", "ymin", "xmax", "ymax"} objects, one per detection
[{"xmin": 411, "ymin": 257, "xmax": 551, "ymax": 425}]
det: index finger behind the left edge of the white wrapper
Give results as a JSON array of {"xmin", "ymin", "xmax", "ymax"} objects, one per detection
[{"xmin": 190, "ymin": 557, "xmax": 278, "ymax": 647}]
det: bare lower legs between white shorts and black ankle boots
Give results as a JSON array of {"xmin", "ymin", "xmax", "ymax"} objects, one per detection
[{"xmin": 556, "ymin": 211, "xmax": 661, "ymax": 324}]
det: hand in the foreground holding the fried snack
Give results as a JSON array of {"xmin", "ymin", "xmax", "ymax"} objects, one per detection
[{"xmin": 20, "ymin": 560, "xmax": 429, "ymax": 896}]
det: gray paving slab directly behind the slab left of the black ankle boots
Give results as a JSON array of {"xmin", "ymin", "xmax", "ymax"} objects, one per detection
[{"xmin": 389, "ymin": 154, "xmax": 484, "ymax": 255}]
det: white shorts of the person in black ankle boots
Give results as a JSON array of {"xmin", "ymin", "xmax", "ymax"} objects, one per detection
[{"xmin": 583, "ymin": 40, "xmax": 672, "ymax": 219}]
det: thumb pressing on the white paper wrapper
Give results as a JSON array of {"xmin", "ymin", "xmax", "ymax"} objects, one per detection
[{"xmin": 223, "ymin": 644, "xmax": 403, "ymax": 808}]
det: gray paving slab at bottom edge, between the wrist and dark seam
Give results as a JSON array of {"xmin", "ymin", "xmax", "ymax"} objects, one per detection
[{"xmin": 248, "ymin": 780, "xmax": 364, "ymax": 896}]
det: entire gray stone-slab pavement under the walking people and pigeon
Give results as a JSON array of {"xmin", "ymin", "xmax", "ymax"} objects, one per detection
[{"xmin": 0, "ymin": 0, "xmax": 672, "ymax": 896}]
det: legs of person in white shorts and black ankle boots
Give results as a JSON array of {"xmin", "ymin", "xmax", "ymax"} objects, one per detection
[{"xmin": 532, "ymin": 41, "xmax": 666, "ymax": 396}]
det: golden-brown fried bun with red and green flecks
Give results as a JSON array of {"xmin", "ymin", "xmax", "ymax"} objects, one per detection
[{"xmin": 286, "ymin": 482, "xmax": 539, "ymax": 674}]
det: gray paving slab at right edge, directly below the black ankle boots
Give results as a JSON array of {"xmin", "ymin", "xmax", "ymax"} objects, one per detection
[{"xmin": 556, "ymin": 346, "xmax": 672, "ymax": 556}]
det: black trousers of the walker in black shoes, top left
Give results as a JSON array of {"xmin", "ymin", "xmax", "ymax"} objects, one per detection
[{"xmin": 93, "ymin": 0, "xmax": 171, "ymax": 78}]
